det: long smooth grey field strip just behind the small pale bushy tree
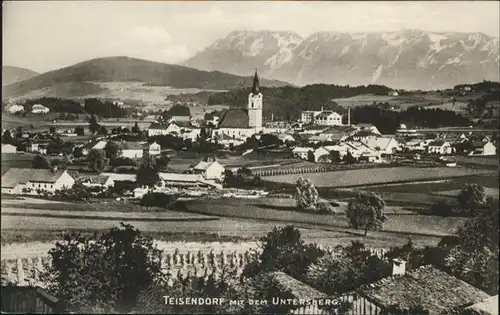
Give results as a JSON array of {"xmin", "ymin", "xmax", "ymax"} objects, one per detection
[{"xmin": 265, "ymin": 167, "xmax": 491, "ymax": 187}]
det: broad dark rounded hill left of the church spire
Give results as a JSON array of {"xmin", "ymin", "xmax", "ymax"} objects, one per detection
[{"xmin": 2, "ymin": 56, "xmax": 289, "ymax": 97}]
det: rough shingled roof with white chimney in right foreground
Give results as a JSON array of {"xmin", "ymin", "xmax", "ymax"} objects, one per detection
[{"xmin": 356, "ymin": 260, "xmax": 490, "ymax": 314}]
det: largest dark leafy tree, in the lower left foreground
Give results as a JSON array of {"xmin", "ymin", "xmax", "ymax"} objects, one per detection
[{"xmin": 44, "ymin": 223, "xmax": 163, "ymax": 313}]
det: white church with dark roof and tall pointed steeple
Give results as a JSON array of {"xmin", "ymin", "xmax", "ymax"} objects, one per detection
[{"xmin": 214, "ymin": 70, "xmax": 263, "ymax": 140}]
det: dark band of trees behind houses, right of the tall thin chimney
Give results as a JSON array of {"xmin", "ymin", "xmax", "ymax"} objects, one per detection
[{"xmin": 351, "ymin": 105, "xmax": 471, "ymax": 134}]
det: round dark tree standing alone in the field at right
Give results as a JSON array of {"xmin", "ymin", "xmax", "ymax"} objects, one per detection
[{"xmin": 346, "ymin": 191, "xmax": 386, "ymax": 236}]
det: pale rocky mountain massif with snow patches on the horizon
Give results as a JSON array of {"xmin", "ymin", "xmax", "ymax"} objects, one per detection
[{"xmin": 182, "ymin": 30, "xmax": 500, "ymax": 89}]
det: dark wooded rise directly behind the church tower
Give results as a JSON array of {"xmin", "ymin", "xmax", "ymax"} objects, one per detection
[{"xmin": 207, "ymin": 84, "xmax": 391, "ymax": 120}]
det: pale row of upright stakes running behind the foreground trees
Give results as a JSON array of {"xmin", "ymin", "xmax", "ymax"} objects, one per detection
[{"xmin": 1, "ymin": 246, "xmax": 387, "ymax": 287}]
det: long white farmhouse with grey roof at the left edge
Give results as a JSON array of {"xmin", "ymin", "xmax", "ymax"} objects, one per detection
[{"xmin": 2, "ymin": 168, "xmax": 75, "ymax": 194}]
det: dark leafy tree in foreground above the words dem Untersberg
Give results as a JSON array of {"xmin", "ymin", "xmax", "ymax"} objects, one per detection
[{"xmin": 243, "ymin": 225, "xmax": 325, "ymax": 279}]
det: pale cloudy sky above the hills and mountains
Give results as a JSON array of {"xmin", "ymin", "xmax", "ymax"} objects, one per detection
[{"xmin": 2, "ymin": 1, "xmax": 500, "ymax": 72}]
